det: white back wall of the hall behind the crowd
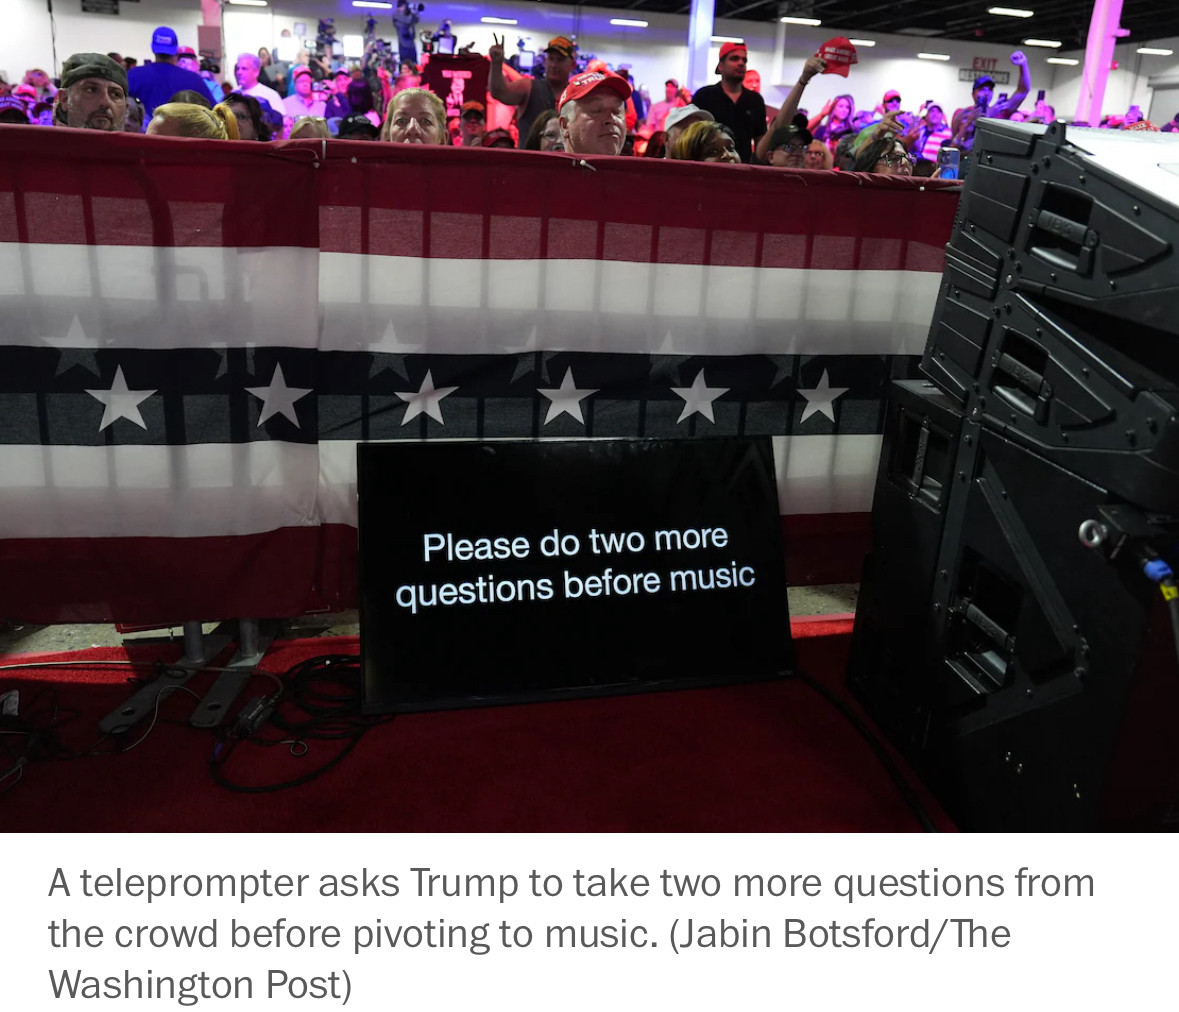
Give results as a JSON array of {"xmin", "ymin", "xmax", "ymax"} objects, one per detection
[{"xmin": 9, "ymin": 0, "xmax": 1179, "ymax": 118}]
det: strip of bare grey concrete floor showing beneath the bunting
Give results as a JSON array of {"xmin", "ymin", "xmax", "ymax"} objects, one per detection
[{"xmin": 0, "ymin": 584, "xmax": 859, "ymax": 657}]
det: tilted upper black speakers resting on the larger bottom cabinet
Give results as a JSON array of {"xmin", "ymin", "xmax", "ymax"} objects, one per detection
[{"xmin": 921, "ymin": 119, "xmax": 1179, "ymax": 513}]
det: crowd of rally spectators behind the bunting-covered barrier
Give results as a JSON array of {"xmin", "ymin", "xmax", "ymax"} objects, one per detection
[{"xmin": 0, "ymin": 27, "xmax": 1179, "ymax": 176}]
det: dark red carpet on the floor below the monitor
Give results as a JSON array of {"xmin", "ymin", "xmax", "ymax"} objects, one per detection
[{"xmin": 0, "ymin": 617, "xmax": 953, "ymax": 833}]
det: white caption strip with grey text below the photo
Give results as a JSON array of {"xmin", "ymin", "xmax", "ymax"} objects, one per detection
[{"xmin": 0, "ymin": 834, "xmax": 1179, "ymax": 1012}]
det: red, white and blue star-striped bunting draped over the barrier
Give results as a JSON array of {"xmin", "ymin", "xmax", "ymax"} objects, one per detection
[{"xmin": 0, "ymin": 127, "xmax": 957, "ymax": 623}]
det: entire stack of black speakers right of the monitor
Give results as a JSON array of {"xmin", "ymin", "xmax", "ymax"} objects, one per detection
[{"xmin": 849, "ymin": 120, "xmax": 1179, "ymax": 832}]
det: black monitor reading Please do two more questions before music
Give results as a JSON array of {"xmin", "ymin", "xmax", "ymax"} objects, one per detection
[{"xmin": 357, "ymin": 438, "xmax": 792, "ymax": 712}]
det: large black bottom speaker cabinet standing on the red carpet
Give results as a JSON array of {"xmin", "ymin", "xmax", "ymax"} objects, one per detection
[{"xmin": 849, "ymin": 377, "xmax": 1179, "ymax": 832}]
